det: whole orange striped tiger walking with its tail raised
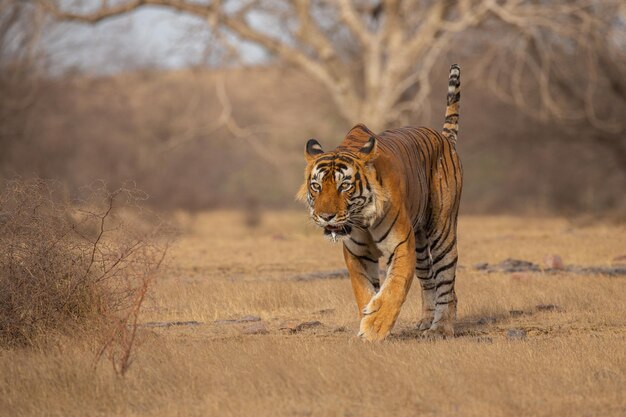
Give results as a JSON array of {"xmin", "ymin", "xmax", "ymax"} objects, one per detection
[{"xmin": 297, "ymin": 64, "xmax": 463, "ymax": 341}]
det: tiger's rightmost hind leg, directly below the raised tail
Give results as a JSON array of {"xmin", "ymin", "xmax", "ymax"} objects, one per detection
[{"xmin": 426, "ymin": 218, "xmax": 458, "ymax": 336}]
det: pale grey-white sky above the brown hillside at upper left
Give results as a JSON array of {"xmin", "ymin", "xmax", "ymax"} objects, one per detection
[{"xmin": 47, "ymin": 7, "xmax": 264, "ymax": 74}]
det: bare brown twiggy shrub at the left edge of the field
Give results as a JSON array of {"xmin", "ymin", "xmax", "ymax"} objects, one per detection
[{"xmin": 0, "ymin": 179, "xmax": 168, "ymax": 374}]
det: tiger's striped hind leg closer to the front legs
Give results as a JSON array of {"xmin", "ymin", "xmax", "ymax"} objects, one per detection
[{"xmin": 415, "ymin": 230, "xmax": 436, "ymax": 331}]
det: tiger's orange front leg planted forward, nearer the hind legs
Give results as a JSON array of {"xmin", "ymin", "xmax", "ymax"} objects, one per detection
[{"xmin": 359, "ymin": 213, "xmax": 415, "ymax": 341}]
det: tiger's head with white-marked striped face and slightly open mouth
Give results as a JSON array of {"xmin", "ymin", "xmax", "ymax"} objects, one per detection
[{"xmin": 297, "ymin": 130, "xmax": 386, "ymax": 241}]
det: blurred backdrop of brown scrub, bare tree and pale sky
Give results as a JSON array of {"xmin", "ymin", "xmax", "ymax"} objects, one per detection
[{"xmin": 0, "ymin": 0, "xmax": 626, "ymax": 216}]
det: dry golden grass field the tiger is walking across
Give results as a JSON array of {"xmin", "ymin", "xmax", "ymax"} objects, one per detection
[{"xmin": 0, "ymin": 211, "xmax": 626, "ymax": 417}]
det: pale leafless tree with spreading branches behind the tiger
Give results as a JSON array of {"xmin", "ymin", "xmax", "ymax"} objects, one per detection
[{"xmin": 37, "ymin": 0, "xmax": 626, "ymax": 162}]
